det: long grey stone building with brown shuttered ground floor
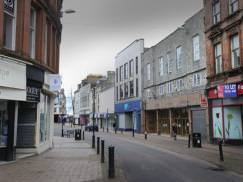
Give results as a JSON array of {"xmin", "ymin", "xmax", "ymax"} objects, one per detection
[{"xmin": 142, "ymin": 10, "xmax": 208, "ymax": 139}]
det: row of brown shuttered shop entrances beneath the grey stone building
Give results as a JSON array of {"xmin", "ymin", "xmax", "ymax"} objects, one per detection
[{"xmin": 145, "ymin": 106, "xmax": 207, "ymax": 139}]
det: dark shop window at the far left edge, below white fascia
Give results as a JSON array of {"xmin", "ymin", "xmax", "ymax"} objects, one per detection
[{"xmin": 0, "ymin": 101, "xmax": 8, "ymax": 147}]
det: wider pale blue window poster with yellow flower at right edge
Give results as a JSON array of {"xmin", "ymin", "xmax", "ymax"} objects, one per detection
[{"xmin": 224, "ymin": 107, "xmax": 242, "ymax": 139}]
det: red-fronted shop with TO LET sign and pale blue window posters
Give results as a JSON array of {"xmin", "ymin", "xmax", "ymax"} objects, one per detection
[{"xmin": 208, "ymin": 83, "xmax": 243, "ymax": 144}]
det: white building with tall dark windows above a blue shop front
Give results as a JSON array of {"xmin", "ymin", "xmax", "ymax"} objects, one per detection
[{"xmin": 115, "ymin": 39, "xmax": 144, "ymax": 132}]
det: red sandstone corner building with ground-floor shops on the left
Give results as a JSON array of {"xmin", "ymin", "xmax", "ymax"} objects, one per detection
[{"xmin": 0, "ymin": 0, "xmax": 62, "ymax": 161}]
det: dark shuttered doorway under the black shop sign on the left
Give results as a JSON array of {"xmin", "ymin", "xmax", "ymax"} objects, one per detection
[{"xmin": 17, "ymin": 102, "xmax": 37, "ymax": 147}]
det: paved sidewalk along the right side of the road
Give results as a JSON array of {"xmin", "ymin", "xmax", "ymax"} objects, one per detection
[{"xmin": 105, "ymin": 131, "xmax": 243, "ymax": 175}]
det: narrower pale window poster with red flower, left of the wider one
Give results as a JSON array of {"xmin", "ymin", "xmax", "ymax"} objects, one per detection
[{"xmin": 213, "ymin": 107, "xmax": 223, "ymax": 138}]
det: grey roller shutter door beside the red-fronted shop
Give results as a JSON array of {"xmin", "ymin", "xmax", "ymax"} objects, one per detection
[{"xmin": 192, "ymin": 110, "xmax": 207, "ymax": 140}]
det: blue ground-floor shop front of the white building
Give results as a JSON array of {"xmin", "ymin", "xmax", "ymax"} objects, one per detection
[{"xmin": 115, "ymin": 100, "xmax": 141, "ymax": 133}]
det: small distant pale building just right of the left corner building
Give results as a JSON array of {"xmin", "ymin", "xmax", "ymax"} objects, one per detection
[{"xmin": 54, "ymin": 89, "xmax": 67, "ymax": 123}]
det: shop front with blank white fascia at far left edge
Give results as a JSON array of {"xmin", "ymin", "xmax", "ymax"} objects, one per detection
[{"xmin": 0, "ymin": 56, "xmax": 26, "ymax": 161}]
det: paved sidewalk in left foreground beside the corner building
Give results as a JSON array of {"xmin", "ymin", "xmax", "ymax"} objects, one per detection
[{"xmin": 0, "ymin": 137, "xmax": 105, "ymax": 182}]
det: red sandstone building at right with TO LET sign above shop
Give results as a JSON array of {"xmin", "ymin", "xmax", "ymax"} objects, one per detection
[{"xmin": 204, "ymin": 0, "xmax": 243, "ymax": 143}]
